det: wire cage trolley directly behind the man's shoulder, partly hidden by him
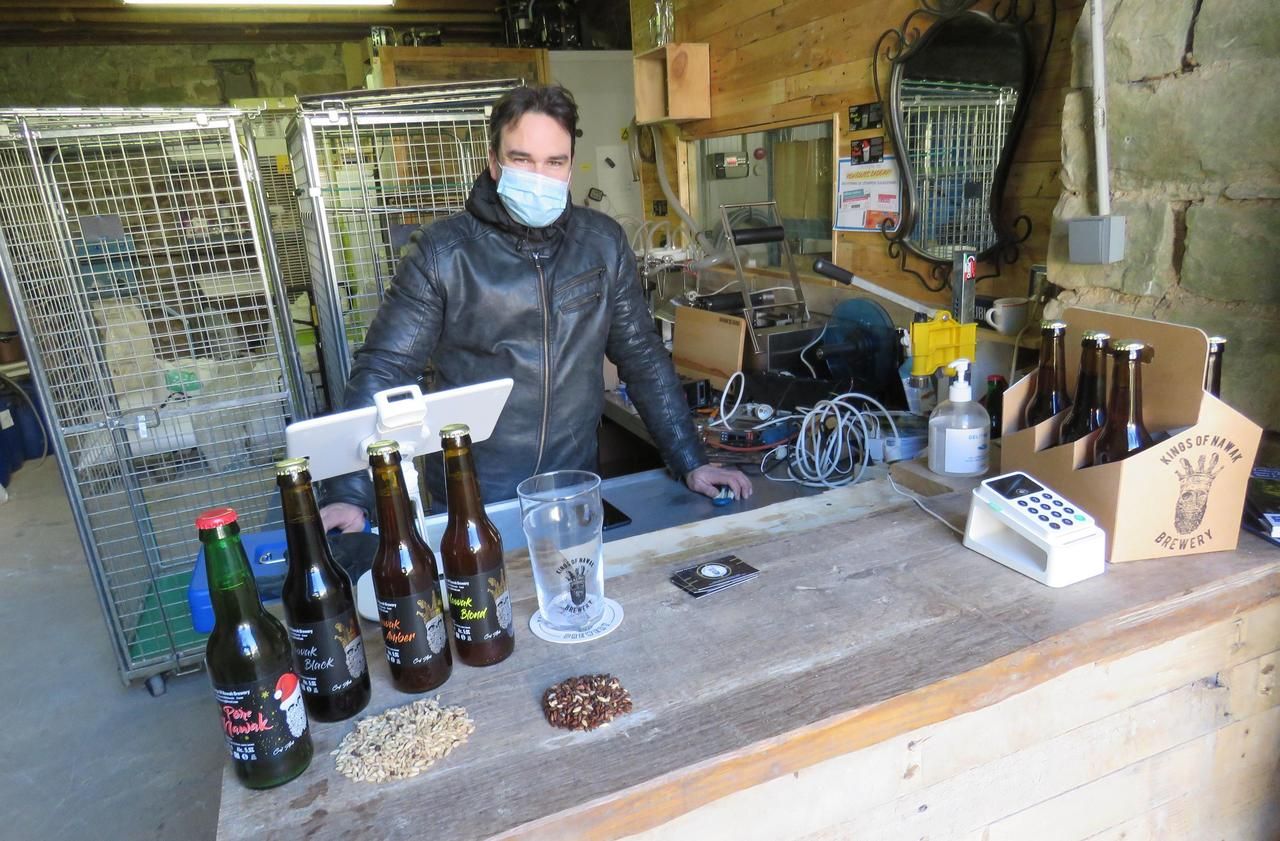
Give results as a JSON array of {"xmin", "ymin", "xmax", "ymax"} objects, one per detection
[{"xmin": 289, "ymin": 79, "xmax": 520, "ymax": 410}]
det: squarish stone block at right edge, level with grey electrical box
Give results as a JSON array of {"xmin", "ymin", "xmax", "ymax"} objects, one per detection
[{"xmin": 1181, "ymin": 201, "xmax": 1280, "ymax": 306}]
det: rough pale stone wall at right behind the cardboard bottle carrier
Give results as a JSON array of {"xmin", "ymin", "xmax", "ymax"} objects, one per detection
[{"xmin": 1048, "ymin": 0, "xmax": 1280, "ymax": 430}]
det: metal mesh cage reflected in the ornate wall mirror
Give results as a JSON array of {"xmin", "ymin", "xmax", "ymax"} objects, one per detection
[{"xmin": 902, "ymin": 82, "xmax": 1018, "ymax": 260}]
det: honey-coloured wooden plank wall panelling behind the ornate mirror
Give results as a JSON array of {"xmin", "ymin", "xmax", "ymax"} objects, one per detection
[{"xmin": 650, "ymin": 0, "xmax": 1085, "ymax": 309}]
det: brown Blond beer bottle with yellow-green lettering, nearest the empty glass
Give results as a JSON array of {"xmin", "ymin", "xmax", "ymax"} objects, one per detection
[{"xmin": 440, "ymin": 424, "xmax": 516, "ymax": 666}]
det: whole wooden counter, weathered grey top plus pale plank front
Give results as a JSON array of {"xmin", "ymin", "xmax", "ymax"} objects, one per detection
[{"xmin": 220, "ymin": 480, "xmax": 1280, "ymax": 841}]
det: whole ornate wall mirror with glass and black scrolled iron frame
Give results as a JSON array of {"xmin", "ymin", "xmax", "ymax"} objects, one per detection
[{"xmin": 873, "ymin": 0, "xmax": 1057, "ymax": 291}]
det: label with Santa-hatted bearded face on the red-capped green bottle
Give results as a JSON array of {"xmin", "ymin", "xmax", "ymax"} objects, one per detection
[{"xmin": 214, "ymin": 672, "xmax": 307, "ymax": 762}]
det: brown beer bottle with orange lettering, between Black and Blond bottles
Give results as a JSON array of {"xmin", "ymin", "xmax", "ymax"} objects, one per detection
[{"xmin": 369, "ymin": 440, "xmax": 453, "ymax": 693}]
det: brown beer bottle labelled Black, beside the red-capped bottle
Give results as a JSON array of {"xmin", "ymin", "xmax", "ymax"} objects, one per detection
[{"xmin": 275, "ymin": 458, "xmax": 370, "ymax": 721}]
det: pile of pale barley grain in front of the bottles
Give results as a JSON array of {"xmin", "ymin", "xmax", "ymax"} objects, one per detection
[{"xmin": 333, "ymin": 698, "xmax": 475, "ymax": 782}]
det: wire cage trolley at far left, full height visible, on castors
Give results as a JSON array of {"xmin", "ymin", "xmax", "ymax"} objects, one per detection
[{"xmin": 0, "ymin": 109, "xmax": 306, "ymax": 694}]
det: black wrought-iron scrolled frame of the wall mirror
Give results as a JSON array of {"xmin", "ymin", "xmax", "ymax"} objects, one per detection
[{"xmin": 872, "ymin": 0, "xmax": 1057, "ymax": 292}]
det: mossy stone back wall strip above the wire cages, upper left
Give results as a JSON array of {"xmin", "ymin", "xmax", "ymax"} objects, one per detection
[{"xmin": 0, "ymin": 44, "xmax": 347, "ymax": 108}]
